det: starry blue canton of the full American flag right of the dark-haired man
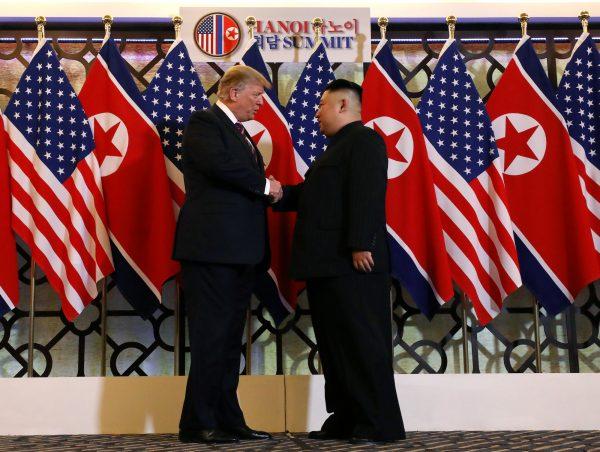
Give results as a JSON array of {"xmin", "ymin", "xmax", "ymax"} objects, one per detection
[{"xmin": 417, "ymin": 41, "xmax": 498, "ymax": 182}]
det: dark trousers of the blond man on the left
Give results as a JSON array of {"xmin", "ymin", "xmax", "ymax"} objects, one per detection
[{"xmin": 179, "ymin": 261, "xmax": 254, "ymax": 430}]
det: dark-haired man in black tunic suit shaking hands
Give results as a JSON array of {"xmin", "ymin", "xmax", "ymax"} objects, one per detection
[{"xmin": 275, "ymin": 79, "xmax": 405, "ymax": 443}]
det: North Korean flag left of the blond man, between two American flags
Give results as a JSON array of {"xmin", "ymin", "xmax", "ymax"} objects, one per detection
[{"xmin": 79, "ymin": 38, "xmax": 179, "ymax": 317}]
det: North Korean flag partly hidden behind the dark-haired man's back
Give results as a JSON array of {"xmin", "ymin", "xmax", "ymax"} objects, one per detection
[{"xmin": 362, "ymin": 40, "xmax": 454, "ymax": 318}]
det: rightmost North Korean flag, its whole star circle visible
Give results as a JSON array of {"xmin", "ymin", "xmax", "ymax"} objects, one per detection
[{"xmin": 487, "ymin": 36, "xmax": 600, "ymax": 314}]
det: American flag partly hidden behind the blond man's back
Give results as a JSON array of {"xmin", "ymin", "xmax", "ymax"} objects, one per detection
[{"xmin": 143, "ymin": 41, "xmax": 210, "ymax": 213}]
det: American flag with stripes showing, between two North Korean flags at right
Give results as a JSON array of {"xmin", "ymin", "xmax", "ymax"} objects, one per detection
[{"xmin": 419, "ymin": 40, "xmax": 521, "ymax": 325}]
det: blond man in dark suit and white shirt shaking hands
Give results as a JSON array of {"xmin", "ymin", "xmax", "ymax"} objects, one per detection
[{"xmin": 173, "ymin": 66, "xmax": 281, "ymax": 443}]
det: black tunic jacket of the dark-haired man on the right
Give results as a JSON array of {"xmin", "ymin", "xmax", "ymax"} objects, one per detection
[{"xmin": 276, "ymin": 121, "xmax": 389, "ymax": 279}]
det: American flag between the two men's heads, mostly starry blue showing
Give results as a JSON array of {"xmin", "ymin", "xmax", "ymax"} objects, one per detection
[{"xmin": 285, "ymin": 43, "xmax": 335, "ymax": 177}]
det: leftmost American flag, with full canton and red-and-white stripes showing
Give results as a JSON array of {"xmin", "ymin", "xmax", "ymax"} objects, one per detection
[{"xmin": 6, "ymin": 41, "xmax": 113, "ymax": 320}]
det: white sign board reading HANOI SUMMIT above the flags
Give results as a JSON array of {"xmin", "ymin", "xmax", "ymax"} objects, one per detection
[{"xmin": 180, "ymin": 6, "xmax": 371, "ymax": 63}]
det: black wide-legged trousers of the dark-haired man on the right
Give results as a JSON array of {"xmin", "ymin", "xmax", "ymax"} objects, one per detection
[{"xmin": 306, "ymin": 273, "xmax": 405, "ymax": 440}]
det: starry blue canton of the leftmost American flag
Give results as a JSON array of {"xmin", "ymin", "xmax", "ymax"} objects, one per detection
[{"xmin": 6, "ymin": 41, "xmax": 94, "ymax": 183}]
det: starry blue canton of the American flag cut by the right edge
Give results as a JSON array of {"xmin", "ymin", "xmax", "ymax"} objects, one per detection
[{"xmin": 556, "ymin": 36, "xmax": 600, "ymax": 168}]
